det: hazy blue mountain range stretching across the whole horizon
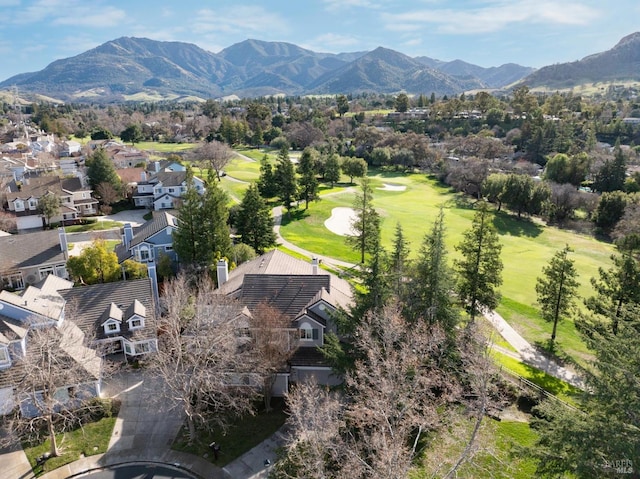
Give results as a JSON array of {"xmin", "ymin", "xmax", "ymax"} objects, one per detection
[{"xmin": 0, "ymin": 33, "xmax": 640, "ymax": 102}]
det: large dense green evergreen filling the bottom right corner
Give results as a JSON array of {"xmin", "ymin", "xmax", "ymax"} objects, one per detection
[{"xmin": 530, "ymin": 308, "xmax": 640, "ymax": 479}]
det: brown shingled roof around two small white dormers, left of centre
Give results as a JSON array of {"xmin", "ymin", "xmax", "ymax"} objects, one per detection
[{"xmin": 60, "ymin": 278, "xmax": 156, "ymax": 341}]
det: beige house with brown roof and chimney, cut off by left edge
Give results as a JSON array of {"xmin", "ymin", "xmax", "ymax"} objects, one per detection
[{"xmin": 0, "ymin": 228, "xmax": 69, "ymax": 290}]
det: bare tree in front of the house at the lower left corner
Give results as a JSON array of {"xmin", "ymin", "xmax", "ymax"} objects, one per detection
[{"xmin": 0, "ymin": 320, "xmax": 103, "ymax": 456}]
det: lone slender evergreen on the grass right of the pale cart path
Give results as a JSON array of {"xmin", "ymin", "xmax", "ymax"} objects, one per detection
[{"xmin": 536, "ymin": 245, "xmax": 579, "ymax": 345}]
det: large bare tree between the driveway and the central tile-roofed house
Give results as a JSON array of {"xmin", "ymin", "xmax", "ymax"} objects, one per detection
[{"xmin": 149, "ymin": 275, "xmax": 260, "ymax": 441}]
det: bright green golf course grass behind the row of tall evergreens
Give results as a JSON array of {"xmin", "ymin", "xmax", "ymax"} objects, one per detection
[{"xmin": 281, "ymin": 172, "xmax": 614, "ymax": 362}]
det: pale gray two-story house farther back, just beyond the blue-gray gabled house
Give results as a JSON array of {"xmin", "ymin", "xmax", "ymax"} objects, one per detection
[{"xmin": 133, "ymin": 171, "xmax": 204, "ymax": 210}]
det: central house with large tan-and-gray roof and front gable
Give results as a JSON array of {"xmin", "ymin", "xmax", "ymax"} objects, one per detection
[{"xmin": 218, "ymin": 250, "xmax": 352, "ymax": 394}]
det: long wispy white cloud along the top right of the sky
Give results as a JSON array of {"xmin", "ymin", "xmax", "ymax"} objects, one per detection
[{"xmin": 383, "ymin": 0, "xmax": 599, "ymax": 34}]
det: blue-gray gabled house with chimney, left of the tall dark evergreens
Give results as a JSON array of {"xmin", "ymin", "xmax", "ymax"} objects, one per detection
[{"xmin": 115, "ymin": 211, "xmax": 178, "ymax": 263}]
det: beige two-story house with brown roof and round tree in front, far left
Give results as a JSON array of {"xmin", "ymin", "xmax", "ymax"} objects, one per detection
[{"xmin": 7, "ymin": 176, "xmax": 98, "ymax": 230}]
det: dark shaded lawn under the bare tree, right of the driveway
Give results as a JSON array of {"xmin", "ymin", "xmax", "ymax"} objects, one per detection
[{"xmin": 172, "ymin": 398, "xmax": 286, "ymax": 467}]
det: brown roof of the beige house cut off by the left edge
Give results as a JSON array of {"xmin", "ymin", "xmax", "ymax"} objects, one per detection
[{"xmin": 0, "ymin": 230, "xmax": 66, "ymax": 272}]
